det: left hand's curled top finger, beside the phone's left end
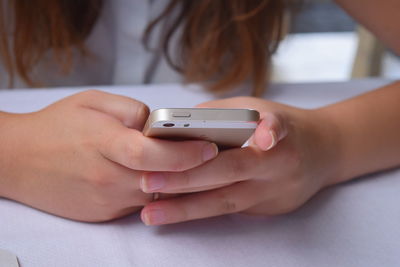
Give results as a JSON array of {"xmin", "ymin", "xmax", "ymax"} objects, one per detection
[{"xmin": 76, "ymin": 90, "xmax": 149, "ymax": 130}]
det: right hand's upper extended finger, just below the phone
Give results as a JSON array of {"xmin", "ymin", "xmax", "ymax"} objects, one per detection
[{"xmin": 140, "ymin": 147, "xmax": 268, "ymax": 193}]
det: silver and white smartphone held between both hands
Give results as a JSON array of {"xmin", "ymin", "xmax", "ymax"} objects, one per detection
[{"xmin": 143, "ymin": 108, "xmax": 260, "ymax": 149}]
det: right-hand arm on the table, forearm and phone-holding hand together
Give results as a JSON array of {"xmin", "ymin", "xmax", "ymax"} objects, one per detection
[{"xmin": 142, "ymin": 83, "xmax": 400, "ymax": 224}]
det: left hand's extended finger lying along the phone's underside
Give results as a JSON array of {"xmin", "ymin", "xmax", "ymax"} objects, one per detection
[{"xmin": 99, "ymin": 128, "xmax": 218, "ymax": 172}]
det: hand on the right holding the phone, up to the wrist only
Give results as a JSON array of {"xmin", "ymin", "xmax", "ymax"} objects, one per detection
[{"xmin": 141, "ymin": 97, "xmax": 338, "ymax": 225}]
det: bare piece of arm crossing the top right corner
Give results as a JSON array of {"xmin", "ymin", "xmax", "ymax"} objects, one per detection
[{"xmin": 336, "ymin": 0, "xmax": 400, "ymax": 55}]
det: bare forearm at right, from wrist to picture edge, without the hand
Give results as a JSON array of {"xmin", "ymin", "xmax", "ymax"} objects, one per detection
[{"xmin": 318, "ymin": 82, "xmax": 400, "ymax": 184}]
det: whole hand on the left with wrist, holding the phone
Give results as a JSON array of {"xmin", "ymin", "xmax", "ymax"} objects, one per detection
[{"xmin": 0, "ymin": 90, "xmax": 218, "ymax": 222}]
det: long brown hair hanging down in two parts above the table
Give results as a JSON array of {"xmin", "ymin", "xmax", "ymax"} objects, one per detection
[{"xmin": 0, "ymin": 0, "xmax": 288, "ymax": 94}]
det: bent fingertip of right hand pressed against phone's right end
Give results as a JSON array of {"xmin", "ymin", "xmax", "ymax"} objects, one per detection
[{"xmin": 251, "ymin": 113, "xmax": 288, "ymax": 151}]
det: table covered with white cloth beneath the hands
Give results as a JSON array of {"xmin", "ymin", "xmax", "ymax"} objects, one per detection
[{"xmin": 0, "ymin": 80, "xmax": 400, "ymax": 267}]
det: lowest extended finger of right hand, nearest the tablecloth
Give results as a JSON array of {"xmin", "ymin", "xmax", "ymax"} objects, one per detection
[{"xmin": 141, "ymin": 181, "xmax": 262, "ymax": 225}]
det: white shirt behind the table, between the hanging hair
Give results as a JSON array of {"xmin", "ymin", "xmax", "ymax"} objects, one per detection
[{"xmin": 0, "ymin": 0, "xmax": 182, "ymax": 88}]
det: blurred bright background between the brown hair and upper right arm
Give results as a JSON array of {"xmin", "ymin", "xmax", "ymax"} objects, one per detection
[{"xmin": 272, "ymin": 0, "xmax": 400, "ymax": 82}]
